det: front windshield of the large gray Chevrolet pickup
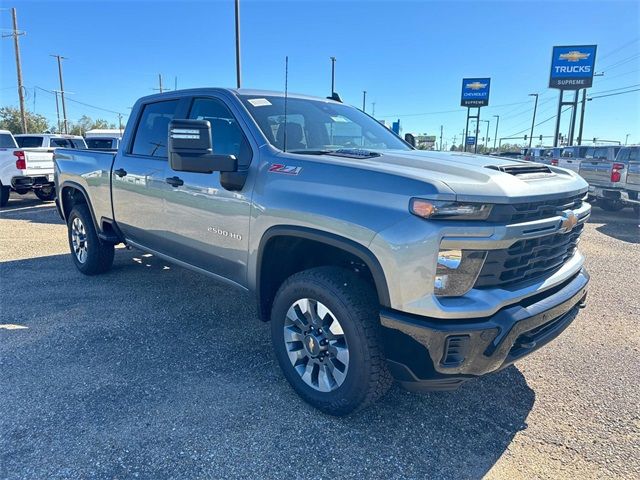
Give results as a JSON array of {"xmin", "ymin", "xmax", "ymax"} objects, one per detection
[{"xmin": 240, "ymin": 95, "xmax": 410, "ymax": 153}]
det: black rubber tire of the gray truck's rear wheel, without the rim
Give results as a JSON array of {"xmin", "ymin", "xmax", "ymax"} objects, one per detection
[{"xmin": 67, "ymin": 203, "xmax": 114, "ymax": 275}]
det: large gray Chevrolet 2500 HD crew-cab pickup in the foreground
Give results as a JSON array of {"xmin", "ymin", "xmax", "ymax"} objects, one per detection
[{"xmin": 55, "ymin": 89, "xmax": 591, "ymax": 415}]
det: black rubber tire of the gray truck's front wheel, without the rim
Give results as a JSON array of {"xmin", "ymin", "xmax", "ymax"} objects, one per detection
[{"xmin": 271, "ymin": 267, "xmax": 393, "ymax": 416}]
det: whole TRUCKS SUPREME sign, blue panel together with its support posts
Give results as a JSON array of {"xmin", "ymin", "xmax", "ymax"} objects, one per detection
[{"xmin": 549, "ymin": 45, "xmax": 597, "ymax": 147}]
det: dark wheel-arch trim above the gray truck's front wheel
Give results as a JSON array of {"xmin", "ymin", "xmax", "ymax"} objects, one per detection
[{"xmin": 256, "ymin": 225, "xmax": 391, "ymax": 308}]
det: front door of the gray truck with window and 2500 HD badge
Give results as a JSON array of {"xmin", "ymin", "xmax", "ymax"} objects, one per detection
[{"xmin": 161, "ymin": 97, "xmax": 252, "ymax": 286}]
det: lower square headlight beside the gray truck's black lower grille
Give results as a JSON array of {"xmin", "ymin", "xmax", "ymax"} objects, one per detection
[{"xmin": 434, "ymin": 250, "xmax": 487, "ymax": 297}]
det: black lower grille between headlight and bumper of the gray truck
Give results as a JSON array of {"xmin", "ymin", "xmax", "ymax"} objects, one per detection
[{"xmin": 475, "ymin": 225, "xmax": 584, "ymax": 288}]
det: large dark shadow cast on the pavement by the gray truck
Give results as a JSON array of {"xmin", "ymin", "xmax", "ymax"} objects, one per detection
[{"xmin": 0, "ymin": 249, "xmax": 535, "ymax": 478}]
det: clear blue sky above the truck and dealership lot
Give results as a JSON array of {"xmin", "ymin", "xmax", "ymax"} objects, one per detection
[{"xmin": 0, "ymin": 0, "xmax": 640, "ymax": 145}]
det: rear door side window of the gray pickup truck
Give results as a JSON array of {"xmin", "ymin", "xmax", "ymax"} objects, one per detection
[{"xmin": 131, "ymin": 100, "xmax": 178, "ymax": 158}]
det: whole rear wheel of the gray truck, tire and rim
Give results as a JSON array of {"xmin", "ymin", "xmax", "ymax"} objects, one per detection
[{"xmin": 67, "ymin": 203, "xmax": 114, "ymax": 275}]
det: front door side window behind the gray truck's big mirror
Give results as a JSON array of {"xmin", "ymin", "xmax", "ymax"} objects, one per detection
[{"xmin": 189, "ymin": 98, "xmax": 251, "ymax": 167}]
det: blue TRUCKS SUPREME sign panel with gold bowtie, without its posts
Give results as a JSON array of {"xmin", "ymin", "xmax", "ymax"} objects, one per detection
[{"xmin": 549, "ymin": 45, "xmax": 597, "ymax": 90}]
